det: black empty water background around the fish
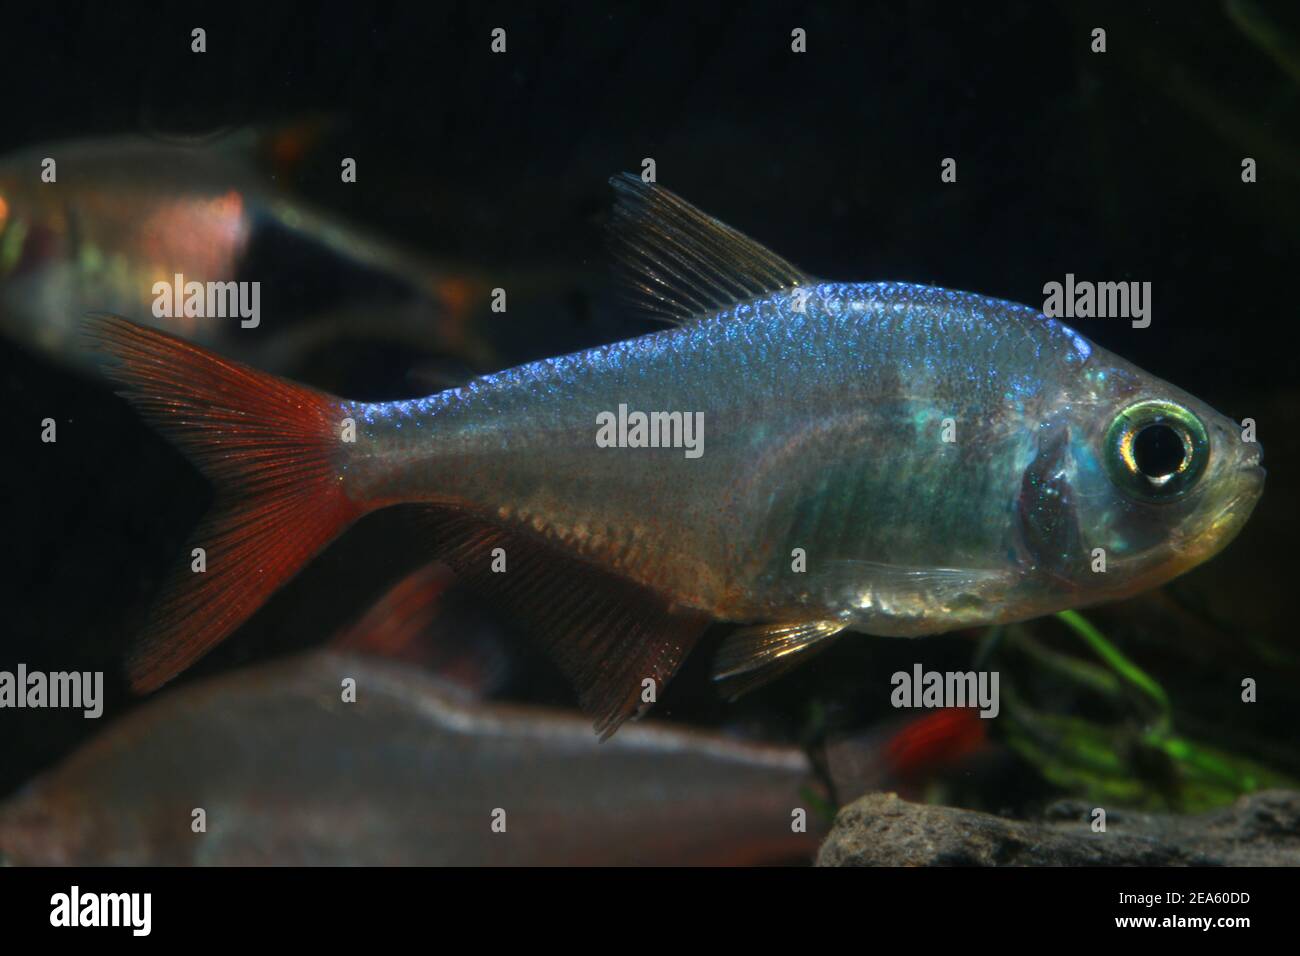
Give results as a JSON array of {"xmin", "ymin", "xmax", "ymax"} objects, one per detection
[{"xmin": 0, "ymin": 0, "xmax": 1300, "ymax": 793}]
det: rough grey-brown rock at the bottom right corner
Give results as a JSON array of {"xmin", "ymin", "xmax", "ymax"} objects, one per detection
[{"xmin": 816, "ymin": 790, "xmax": 1300, "ymax": 866}]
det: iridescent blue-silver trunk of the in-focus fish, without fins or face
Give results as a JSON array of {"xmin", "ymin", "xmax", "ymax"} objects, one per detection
[{"xmin": 343, "ymin": 284, "xmax": 1253, "ymax": 636}]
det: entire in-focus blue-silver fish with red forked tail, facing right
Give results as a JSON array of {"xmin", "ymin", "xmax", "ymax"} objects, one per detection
[{"xmin": 89, "ymin": 178, "xmax": 1264, "ymax": 734}]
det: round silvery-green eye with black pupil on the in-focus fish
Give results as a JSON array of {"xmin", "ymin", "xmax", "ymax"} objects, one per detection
[{"xmin": 1105, "ymin": 399, "xmax": 1210, "ymax": 501}]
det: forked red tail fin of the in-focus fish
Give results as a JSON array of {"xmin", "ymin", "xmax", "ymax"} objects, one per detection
[{"xmin": 86, "ymin": 316, "xmax": 364, "ymax": 692}]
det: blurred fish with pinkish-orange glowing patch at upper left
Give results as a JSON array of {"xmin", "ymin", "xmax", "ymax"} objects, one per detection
[{"xmin": 0, "ymin": 121, "xmax": 506, "ymax": 369}]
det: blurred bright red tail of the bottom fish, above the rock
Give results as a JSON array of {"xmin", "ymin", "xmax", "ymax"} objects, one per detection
[{"xmin": 826, "ymin": 708, "xmax": 988, "ymax": 804}]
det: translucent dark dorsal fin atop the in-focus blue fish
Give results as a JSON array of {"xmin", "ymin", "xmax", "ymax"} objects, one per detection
[{"xmin": 610, "ymin": 173, "xmax": 811, "ymax": 325}]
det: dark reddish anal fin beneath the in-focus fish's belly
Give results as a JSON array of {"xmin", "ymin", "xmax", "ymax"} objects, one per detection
[{"xmin": 430, "ymin": 510, "xmax": 710, "ymax": 740}]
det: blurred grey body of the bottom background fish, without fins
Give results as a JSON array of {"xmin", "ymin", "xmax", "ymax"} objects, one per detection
[{"xmin": 0, "ymin": 652, "xmax": 819, "ymax": 866}]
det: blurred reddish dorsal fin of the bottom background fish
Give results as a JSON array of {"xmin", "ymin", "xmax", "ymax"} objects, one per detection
[{"xmin": 330, "ymin": 561, "xmax": 508, "ymax": 697}]
